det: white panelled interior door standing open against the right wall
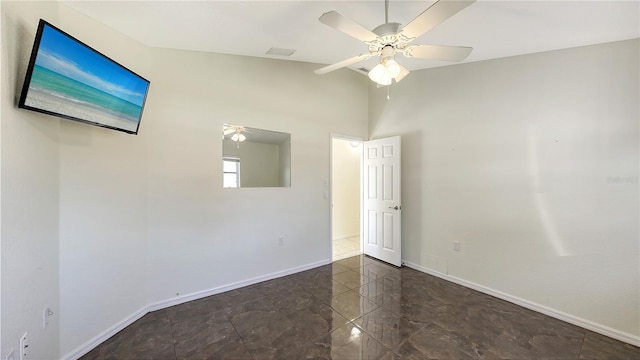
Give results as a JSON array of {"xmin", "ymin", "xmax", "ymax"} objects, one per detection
[{"xmin": 362, "ymin": 136, "xmax": 402, "ymax": 266}]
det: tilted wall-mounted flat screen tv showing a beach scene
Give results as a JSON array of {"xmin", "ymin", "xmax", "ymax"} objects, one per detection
[{"xmin": 18, "ymin": 20, "xmax": 149, "ymax": 134}]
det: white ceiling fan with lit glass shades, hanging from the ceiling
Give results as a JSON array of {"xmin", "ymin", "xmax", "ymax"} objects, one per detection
[{"xmin": 314, "ymin": 0, "xmax": 476, "ymax": 86}]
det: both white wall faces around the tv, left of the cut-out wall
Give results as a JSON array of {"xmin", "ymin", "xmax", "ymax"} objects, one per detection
[{"xmin": 2, "ymin": 1, "xmax": 153, "ymax": 359}]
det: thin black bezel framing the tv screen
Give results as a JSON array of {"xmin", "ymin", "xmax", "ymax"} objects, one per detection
[{"xmin": 18, "ymin": 19, "xmax": 151, "ymax": 135}]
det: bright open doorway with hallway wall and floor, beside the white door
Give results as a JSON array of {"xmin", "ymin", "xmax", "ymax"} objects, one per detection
[{"xmin": 331, "ymin": 136, "xmax": 363, "ymax": 261}]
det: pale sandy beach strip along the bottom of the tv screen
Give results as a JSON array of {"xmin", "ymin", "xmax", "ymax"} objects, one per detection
[{"xmin": 25, "ymin": 88, "xmax": 138, "ymax": 132}]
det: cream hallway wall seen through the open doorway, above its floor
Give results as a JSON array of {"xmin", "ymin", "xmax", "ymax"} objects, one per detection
[{"xmin": 331, "ymin": 138, "xmax": 362, "ymax": 240}]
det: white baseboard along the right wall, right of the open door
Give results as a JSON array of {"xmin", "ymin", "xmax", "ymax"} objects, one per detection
[{"xmin": 402, "ymin": 260, "xmax": 640, "ymax": 346}]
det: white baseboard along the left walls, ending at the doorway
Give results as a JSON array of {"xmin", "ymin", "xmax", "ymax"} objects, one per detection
[{"xmin": 61, "ymin": 260, "xmax": 331, "ymax": 360}]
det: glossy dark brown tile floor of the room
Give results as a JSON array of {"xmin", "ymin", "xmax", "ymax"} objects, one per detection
[{"xmin": 82, "ymin": 256, "xmax": 640, "ymax": 360}]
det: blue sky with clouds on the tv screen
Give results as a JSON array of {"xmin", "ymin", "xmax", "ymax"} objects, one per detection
[{"xmin": 36, "ymin": 24, "xmax": 148, "ymax": 106}]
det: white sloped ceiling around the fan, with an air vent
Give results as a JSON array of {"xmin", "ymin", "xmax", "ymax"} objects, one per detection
[{"xmin": 63, "ymin": 0, "xmax": 640, "ymax": 74}]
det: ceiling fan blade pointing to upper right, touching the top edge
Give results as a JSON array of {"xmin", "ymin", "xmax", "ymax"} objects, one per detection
[{"xmin": 402, "ymin": 0, "xmax": 476, "ymax": 38}]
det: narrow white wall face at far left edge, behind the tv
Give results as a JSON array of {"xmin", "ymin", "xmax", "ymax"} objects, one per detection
[{"xmin": 0, "ymin": 1, "xmax": 60, "ymax": 359}]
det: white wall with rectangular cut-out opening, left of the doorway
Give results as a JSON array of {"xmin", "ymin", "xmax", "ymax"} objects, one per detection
[{"xmin": 144, "ymin": 45, "xmax": 367, "ymax": 302}]
